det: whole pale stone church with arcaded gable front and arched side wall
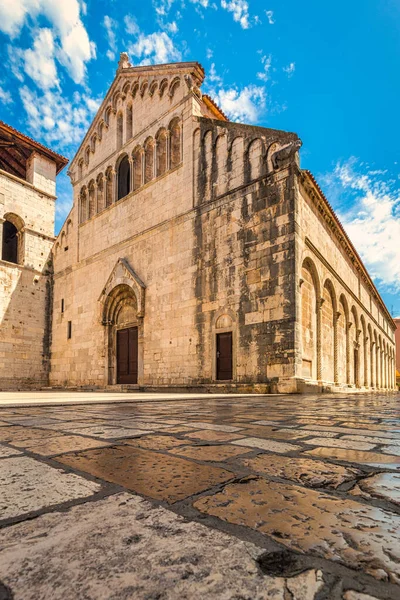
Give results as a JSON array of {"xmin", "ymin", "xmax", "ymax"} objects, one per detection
[{"xmin": 0, "ymin": 54, "xmax": 395, "ymax": 393}]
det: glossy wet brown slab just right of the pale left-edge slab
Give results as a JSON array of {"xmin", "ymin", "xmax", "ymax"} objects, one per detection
[{"xmin": 57, "ymin": 446, "xmax": 234, "ymax": 504}]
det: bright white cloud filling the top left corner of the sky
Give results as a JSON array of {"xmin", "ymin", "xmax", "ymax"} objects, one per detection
[{"xmin": 0, "ymin": 0, "xmax": 96, "ymax": 83}]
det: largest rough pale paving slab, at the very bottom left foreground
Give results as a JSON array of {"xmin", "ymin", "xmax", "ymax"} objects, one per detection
[{"xmin": 0, "ymin": 493, "xmax": 324, "ymax": 600}]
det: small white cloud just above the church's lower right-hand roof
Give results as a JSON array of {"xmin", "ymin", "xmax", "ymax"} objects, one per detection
[{"xmin": 211, "ymin": 85, "xmax": 266, "ymax": 123}]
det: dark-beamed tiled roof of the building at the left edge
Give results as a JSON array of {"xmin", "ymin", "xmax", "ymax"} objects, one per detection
[{"xmin": 0, "ymin": 120, "xmax": 68, "ymax": 177}]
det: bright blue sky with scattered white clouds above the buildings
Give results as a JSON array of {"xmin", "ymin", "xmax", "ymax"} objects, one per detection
[{"xmin": 0, "ymin": 0, "xmax": 400, "ymax": 316}]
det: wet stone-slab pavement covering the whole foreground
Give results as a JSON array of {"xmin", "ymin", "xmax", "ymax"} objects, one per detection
[{"xmin": 0, "ymin": 393, "xmax": 400, "ymax": 600}]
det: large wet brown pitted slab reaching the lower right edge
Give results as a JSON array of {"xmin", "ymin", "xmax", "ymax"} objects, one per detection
[{"xmin": 194, "ymin": 477, "xmax": 400, "ymax": 582}]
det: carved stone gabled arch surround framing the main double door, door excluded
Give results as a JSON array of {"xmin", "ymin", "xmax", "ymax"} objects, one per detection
[{"xmin": 99, "ymin": 258, "xmax": 146, "ymax": 385}]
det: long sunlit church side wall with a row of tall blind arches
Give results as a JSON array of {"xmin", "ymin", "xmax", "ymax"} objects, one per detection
[{"xmin": 296, "ymin": 172, "xmax": 395, "ymax": 389}]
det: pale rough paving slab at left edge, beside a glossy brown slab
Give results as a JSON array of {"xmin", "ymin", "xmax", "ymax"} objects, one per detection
[{"xmin": 0, "ymin": 456, "xmax": 100, "ymax": 520}]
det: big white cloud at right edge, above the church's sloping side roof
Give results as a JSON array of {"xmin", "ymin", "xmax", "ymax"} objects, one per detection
[{"xmin": 325, "ymin": 158, "xmax": 400, "ymax": 292}]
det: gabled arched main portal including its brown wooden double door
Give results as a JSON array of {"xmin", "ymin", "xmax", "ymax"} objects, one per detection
[{"xmin": 99, "ymin": 259, "xmax": 144, "ymax": 385}]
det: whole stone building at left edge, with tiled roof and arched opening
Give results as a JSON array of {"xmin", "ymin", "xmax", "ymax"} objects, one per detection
[{"xmin": 0, "ymin": 122, "xmax": 68, "ymax": 389}]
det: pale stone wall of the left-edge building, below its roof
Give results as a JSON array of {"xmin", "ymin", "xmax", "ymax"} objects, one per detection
[{"xmin": 0, "ymin": 168, "xmax": 55, "ymax": 389}]
